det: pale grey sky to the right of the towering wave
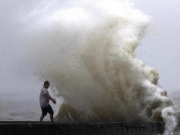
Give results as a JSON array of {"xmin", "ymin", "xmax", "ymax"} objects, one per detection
[{"xmin": 133, "ymin": 0, "xmax": 180, "ymax": 92}]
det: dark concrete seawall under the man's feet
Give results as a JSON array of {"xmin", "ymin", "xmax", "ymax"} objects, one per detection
[{"xmin": 0, "ymin": 121, "xmax": 164, "ymax": 135}]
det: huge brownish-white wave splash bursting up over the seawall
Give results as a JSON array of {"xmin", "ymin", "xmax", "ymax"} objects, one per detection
[{"xmin": 26, "ymin": 0, "xmax": 177, "ymax": 135}]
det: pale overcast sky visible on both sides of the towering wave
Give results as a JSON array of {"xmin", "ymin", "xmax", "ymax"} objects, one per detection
[{"xmin": 0, "ymin": 0, "xmax": 180, "ymax": 104}]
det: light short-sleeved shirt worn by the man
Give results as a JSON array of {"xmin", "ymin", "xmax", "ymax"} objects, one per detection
[{"xmin": 39, "ymin": 87, "xmax": 49, "ymax": 107}]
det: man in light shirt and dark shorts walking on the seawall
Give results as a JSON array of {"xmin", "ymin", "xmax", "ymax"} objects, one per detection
[{"xmin": 39, "ymin": 81, "xmax": 56, "ymax": 123}]
